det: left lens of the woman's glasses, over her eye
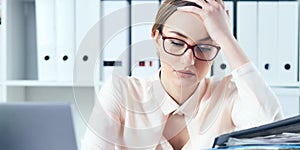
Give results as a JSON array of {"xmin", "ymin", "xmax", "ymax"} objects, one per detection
[{"xmin": 164, "ymin": 39, "xmax": 187, "ymax": 55}]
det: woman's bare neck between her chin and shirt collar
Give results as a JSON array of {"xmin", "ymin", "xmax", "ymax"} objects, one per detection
[{"xmin": 160, "ymin": 72, "xmax": 198, "ymax": 105}]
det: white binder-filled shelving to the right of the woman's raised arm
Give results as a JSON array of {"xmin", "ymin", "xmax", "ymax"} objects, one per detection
[{"xmin": 236, "ymin": 0, "xmax": 300, "ymax": 117}]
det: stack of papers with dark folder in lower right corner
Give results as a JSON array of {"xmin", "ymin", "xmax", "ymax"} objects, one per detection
[{"xmin": 213, "ymin": 116, "xmax": 300, "ymax": 150}]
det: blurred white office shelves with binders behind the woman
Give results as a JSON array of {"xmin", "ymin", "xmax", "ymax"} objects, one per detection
[{"xmin": 0, "ymin": 0, "xmax": 300, "ymax": 148}]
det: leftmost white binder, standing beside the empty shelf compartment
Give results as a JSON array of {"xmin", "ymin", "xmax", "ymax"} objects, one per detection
[{"xmin": 35, "ymin": 0, "xmax": 57, "ymax": 81}]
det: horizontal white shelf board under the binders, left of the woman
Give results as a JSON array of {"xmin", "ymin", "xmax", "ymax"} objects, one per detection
[{"xmin": 4, "ymin": 80, "xmax": 103, "ymax": 87}]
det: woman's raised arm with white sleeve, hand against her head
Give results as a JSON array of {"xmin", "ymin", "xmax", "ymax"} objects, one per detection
[{"xmin": 178, "ymin": 0, "xmax": 282, "ymax": 128}]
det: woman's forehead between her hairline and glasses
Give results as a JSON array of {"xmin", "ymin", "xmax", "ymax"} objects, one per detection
[{"xmin": 164, "ymin": 11, "xmax": 208, "ymax": 40}]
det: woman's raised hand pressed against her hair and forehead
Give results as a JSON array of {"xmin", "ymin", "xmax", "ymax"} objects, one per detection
[{"xmin": 178, "ymin": 0, "xmax": 233, "ymax": 45}]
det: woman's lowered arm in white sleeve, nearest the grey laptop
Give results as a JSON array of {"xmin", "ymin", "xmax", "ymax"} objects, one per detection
[{"xmin": 81, "ymin": 84, "xmax": 121, "ymax": 150}]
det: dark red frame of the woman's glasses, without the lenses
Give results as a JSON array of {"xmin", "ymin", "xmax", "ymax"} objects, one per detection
[{"xmin": 161, "ymin": 34, "xmax": 221, "ymax": 61}]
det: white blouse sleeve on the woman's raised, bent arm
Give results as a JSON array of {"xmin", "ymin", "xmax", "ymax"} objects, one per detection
[{"xmin": 232, "ymin": 62, "xmax": 283, "ymax": 129}]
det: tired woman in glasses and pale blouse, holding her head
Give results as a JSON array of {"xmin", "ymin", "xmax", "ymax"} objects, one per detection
[{"xmin": 82, "ymin": 0, "xmax": 282, "ymax": 150}]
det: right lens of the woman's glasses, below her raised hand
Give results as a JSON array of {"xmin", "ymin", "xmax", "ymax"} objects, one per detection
[{"xmin": 194, "ymin": 44, "xmax": 218, "ymax": 60}]
